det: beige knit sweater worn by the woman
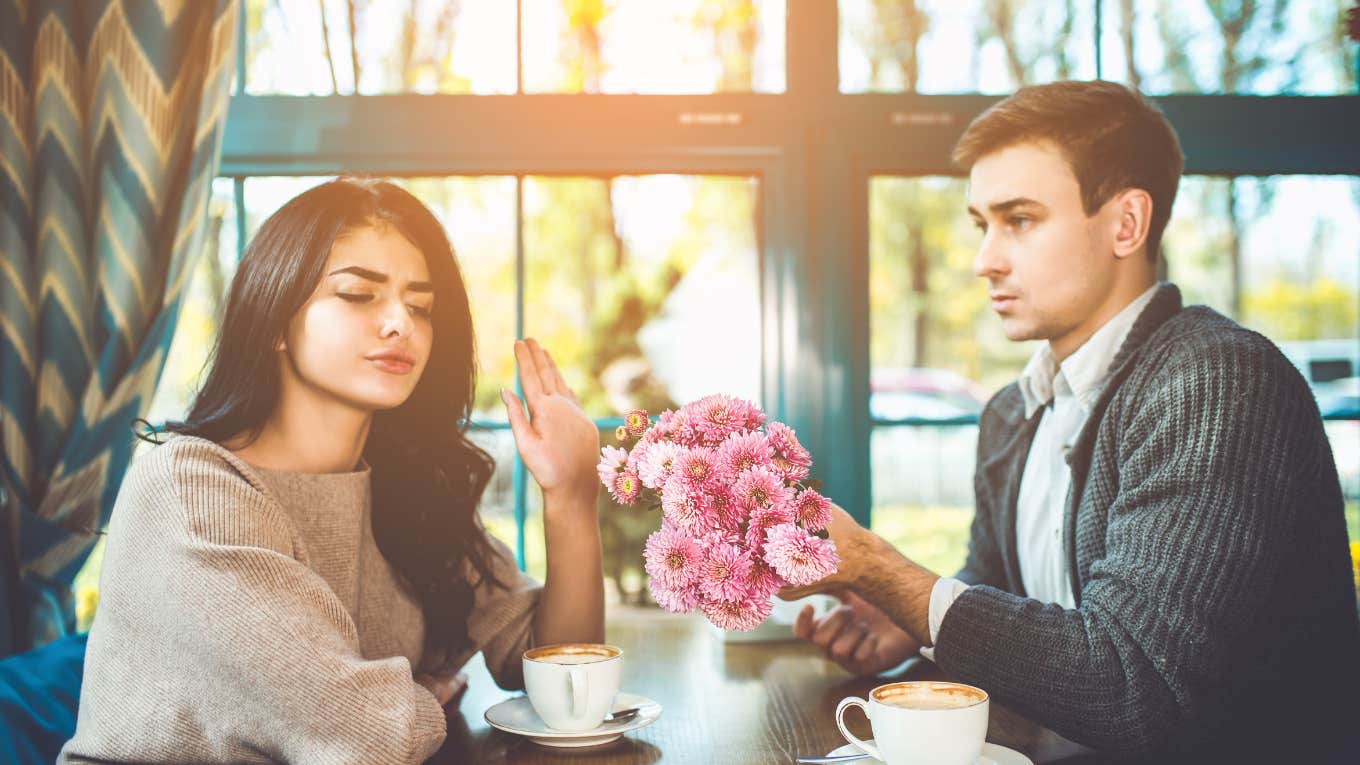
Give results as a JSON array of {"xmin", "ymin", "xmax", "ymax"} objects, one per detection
[{"xmin": 58, "ymin": 436, "xmax": 540, "ymax": 764}]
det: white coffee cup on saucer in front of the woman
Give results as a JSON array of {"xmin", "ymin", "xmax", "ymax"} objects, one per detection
[{"xmin": 524, "ymin": 642, "xmax": 623, "ymax": 732}]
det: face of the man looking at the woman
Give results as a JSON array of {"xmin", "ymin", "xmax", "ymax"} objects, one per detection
[{"xmin": 968, "ymin": 143, "xmax": 1118, "ymax": 358}]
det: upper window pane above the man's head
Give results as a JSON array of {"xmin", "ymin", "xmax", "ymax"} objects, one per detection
[{"xmin": 839, "ymin": 0, "xmax": 1355, "ymax": 95}]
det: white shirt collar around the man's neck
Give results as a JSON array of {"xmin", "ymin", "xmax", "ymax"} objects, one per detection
[{"xmin": 1019, "ymin": 284, "xmax": 1157, "ymax": 419}]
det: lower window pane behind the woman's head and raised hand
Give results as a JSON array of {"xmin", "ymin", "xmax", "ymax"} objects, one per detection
[{"xmin": 140, "ymin": 176, "xmax": 760, "ymax": 582}]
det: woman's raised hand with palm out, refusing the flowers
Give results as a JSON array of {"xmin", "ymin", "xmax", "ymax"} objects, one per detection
[{"xmin": 500, "ymin": 338, "xmax": 600, "ymax": 508}]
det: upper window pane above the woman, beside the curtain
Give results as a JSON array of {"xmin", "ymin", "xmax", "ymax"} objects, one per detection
[{"xmin": 245, "ymin": 0, "xmax": 785, "ymax": 95}]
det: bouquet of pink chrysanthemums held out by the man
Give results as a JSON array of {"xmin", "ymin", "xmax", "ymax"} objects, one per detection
[{"xmin": 598, "ymin": 395, "xmax": 840, "ymax": 630}]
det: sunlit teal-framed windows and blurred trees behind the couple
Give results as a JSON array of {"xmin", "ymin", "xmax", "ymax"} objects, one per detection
[{"xmin": 66, "ymin": 0, "xmax": 1360, "ymax": 629}]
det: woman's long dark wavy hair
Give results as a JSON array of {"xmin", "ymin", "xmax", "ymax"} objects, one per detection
[{"xmin": 165, "ymin": 178, "xmax": 502, "ymax": 648}]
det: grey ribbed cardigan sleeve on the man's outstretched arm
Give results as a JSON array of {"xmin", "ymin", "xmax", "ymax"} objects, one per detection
[{"xmin": 936, "ymin": 331, "xmax": 1326, "ymax": 751}]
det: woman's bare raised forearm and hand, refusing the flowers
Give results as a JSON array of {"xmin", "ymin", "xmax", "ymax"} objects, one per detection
[{"xmin": 502, "ymin": 339, "xmax": 604, "ymax": 645}]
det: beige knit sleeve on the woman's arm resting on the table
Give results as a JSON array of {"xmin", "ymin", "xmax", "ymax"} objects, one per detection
[{"xmin": 64, "ymin": 441, "xmax": 445, "ymax": 764}]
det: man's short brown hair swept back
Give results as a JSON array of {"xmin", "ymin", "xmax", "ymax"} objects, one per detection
[{"xmin": 953, "ymin": 80, "xmax": 1185, "ymax": 259}]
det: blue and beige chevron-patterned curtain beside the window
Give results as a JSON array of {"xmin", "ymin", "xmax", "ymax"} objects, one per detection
[{"xmin": 0, "ymin": 0, "xmax": 239, "ymax": 655}]
